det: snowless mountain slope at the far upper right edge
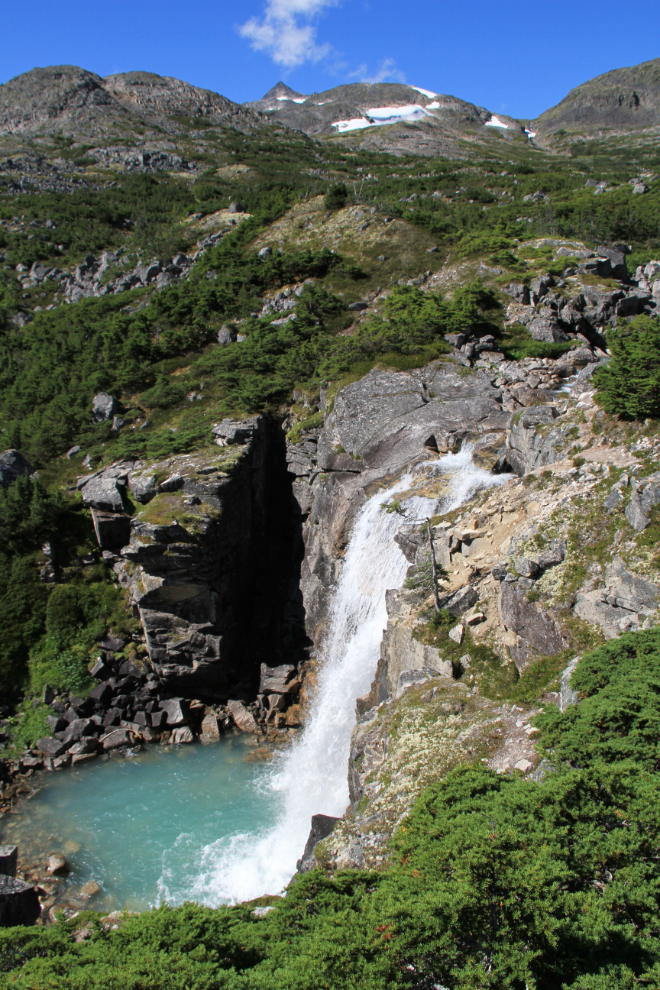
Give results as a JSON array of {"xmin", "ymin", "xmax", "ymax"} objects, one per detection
[{"xmin": 532, "ymin": 58, "xmax": 660, "ymax": 144}]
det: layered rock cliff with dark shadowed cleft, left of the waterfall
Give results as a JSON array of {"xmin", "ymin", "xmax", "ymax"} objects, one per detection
[{"xmin": 78, "ymin": 417, "xmax": 297, "ymax": 701}]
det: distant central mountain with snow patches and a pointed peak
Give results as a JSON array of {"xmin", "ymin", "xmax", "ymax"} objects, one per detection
[{"xmin": 245, "ymin": 82, "xmax": 527, "ymax": 157}]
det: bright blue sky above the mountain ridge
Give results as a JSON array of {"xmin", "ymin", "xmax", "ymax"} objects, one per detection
[{"xmin": 0, "ymin": 0, "xmax": 660, "ymax": 118}]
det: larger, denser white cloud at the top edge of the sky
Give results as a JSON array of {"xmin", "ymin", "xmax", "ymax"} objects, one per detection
[{"xmin": 238, "ymin": 0, "xmax": 339, "ymax": 69}]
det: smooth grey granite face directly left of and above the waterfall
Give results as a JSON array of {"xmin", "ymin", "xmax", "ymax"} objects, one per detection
[{"xmin": 296, "ymin": 360, "xmax": 512, "ymax": 644}]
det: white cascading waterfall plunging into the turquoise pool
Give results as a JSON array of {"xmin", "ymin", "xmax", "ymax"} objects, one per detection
[{"xmin": 178, "ymin": 448, "xmax": 506, "ymax": 905}]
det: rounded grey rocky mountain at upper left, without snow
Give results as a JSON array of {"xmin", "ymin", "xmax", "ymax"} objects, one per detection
[{"xmin": 0, "ymin": 65, "xmax": 265, "ymax": 153}]
